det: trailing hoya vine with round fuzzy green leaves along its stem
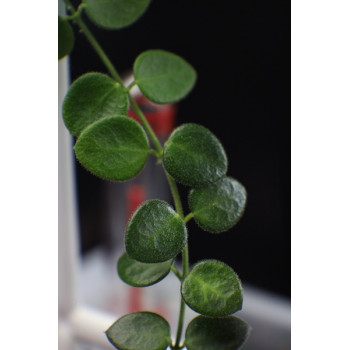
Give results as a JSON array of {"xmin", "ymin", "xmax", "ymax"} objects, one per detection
[{"xmin": 58, "ymin": 0, "xmax": 250, "ymax": 350}]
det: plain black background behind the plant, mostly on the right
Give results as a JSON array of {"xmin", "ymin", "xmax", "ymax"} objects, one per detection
[{"xmin": 67, "ymin": 0, "xmax": 291, "ymax": 296}]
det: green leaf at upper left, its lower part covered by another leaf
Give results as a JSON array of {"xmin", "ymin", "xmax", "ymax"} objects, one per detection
[{"xmin": 62, "ymin": 73, "xmax": 128, "ymax": 136}]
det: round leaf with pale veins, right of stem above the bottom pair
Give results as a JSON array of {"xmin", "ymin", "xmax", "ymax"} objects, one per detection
[{"xmin": 181, "ymin": 260, "xmax": 243, "ymax": 317}]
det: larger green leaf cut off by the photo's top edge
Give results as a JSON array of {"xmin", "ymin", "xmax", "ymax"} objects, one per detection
[{"xmin": 83, "ymin": 0, "xmax": 151, "ymax": 29}]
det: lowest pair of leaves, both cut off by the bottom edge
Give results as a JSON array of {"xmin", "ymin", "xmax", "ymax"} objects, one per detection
[{"xmin": 106, "ymin": 312, "xmax": 250, "ymax": 350}]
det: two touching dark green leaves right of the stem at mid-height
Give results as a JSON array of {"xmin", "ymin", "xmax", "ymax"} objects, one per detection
[{"xmin": 163, "ymin": 124, "xmax": 247, "ymax": 233}]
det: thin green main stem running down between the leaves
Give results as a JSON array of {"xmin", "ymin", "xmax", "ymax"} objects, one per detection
[{"xmin": 64, "ymin": 0, "xmax": 189, "ymax": 349}]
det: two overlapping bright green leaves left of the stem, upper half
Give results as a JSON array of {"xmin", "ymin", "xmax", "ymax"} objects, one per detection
[{"xmin": 62, "ymin": 73, "xmax": 149, "ymax": 181}]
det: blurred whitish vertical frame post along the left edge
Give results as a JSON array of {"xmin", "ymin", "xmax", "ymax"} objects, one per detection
[{"xmin": 58, "ymin": 58, "xmax": 79, "ymax": 316}]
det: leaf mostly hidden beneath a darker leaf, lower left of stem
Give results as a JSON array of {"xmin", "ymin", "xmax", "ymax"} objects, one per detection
[{"xmin": 117, "ymin": 253, "xmax": 173, "ymax": 287}]
